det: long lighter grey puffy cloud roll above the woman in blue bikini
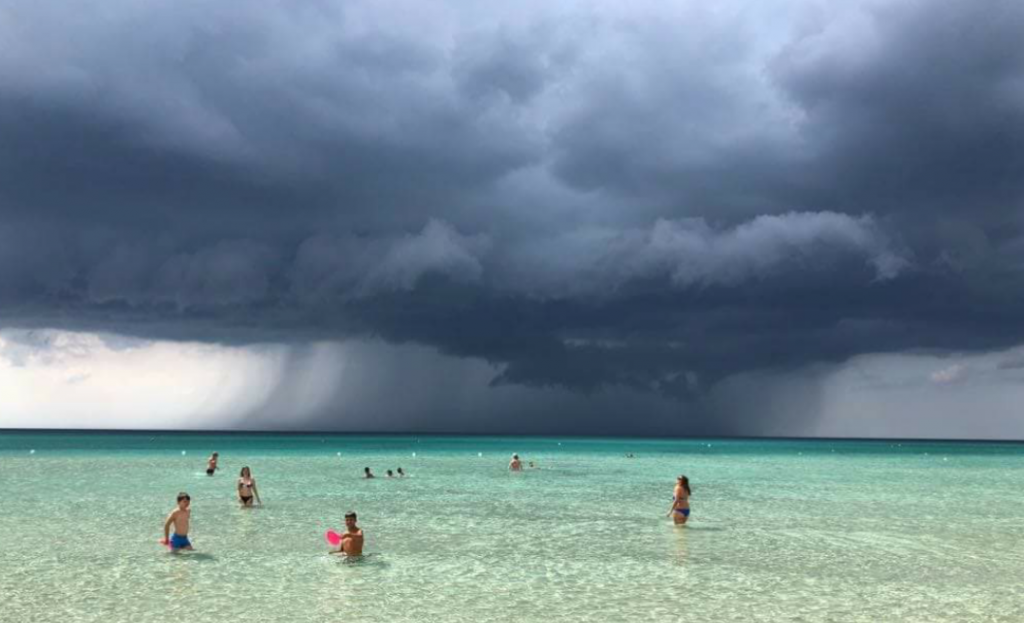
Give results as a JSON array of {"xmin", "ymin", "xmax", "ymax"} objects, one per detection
[{"xmin": 501, "ymin": 212, "xmax": 911, "ymax": 296}]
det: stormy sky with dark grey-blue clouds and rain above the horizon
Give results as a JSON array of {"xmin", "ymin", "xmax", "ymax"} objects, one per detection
[{"xmin": 0, "ymin": 0, "xmax": 1024, "ymax": 439}]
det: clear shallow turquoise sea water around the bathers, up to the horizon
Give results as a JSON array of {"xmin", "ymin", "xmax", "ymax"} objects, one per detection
[{"xmin": 0, "ymin": 431, "xmax": 1024, "ymax": 622}]
